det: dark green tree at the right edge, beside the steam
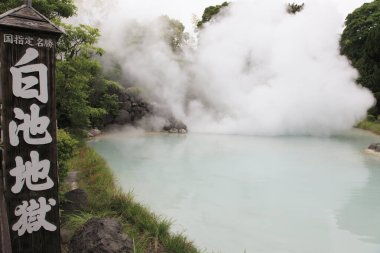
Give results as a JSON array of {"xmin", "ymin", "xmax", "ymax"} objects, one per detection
[{"xmin": 340, "ymin": 0, "xmax": 380, "ymax": 115}]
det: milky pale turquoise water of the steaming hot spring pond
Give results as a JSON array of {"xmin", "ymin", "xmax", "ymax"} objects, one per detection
[{"xmin": 90, "ymin": 130, "xmax": 380, "ymax": 253}]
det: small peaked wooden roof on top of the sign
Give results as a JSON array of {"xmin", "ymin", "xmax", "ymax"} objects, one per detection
[{"xmin": 0, "ymin": 5, "xmax": 63, "ymax": 34}]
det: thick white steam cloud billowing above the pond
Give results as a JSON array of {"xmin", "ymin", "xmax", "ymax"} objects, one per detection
[{"xmin": 71, "ymin": 0, "xmax": 374, "ymax": 135}]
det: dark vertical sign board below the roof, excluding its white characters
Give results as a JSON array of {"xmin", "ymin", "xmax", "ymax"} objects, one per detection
[{"xmin": 0, "ymin": 25, "xmax": 60, "ymax": 253}]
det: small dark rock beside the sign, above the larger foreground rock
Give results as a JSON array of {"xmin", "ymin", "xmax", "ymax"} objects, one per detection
[{"xmin": 62, "ymin": 189, "xmax": 88, "ymax": 214}]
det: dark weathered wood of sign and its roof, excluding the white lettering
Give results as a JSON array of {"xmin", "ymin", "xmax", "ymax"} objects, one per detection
[{"xmin": 0, "ymin": 4, "xmax": 61, "ymax": 253}]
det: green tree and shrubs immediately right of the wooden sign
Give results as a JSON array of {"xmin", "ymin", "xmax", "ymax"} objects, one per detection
[{"xmin": 57, "ymin": 25, "xmax": 123, "ymax": 129}]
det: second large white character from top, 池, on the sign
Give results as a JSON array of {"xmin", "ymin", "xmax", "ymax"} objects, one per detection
[{"xmin": 9, "ymin": 104, "xmax": 52, "ymax": 147}]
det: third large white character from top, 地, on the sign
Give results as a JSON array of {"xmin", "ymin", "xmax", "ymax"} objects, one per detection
[{"xmin": 9, "ymin": 151, "xmax": 54, "ymax": 193}]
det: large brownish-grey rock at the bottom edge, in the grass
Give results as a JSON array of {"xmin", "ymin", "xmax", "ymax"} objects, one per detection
[{"xmin": 70, "ymin": 218, "xmax": 133, "ymax": 253}]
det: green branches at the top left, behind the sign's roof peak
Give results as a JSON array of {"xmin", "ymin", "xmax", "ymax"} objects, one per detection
[{"xmin": 0, "ymin": 0, "xmax": 76, "ymax": 20}]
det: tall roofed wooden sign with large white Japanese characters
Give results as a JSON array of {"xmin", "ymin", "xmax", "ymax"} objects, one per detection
[{"xmin": 0, "ymin": 5, "xmax": 62, "ymax": 253}]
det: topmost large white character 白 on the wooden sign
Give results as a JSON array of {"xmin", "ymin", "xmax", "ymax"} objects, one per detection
[{"xmin": 10, "ymin": 48, "xmax": 48, "ymax": 103}]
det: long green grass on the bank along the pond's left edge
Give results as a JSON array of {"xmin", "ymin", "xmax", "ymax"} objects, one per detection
[{"xmin": 63, "ymin": 146, "xmax": 201, "ymax": 253}]
